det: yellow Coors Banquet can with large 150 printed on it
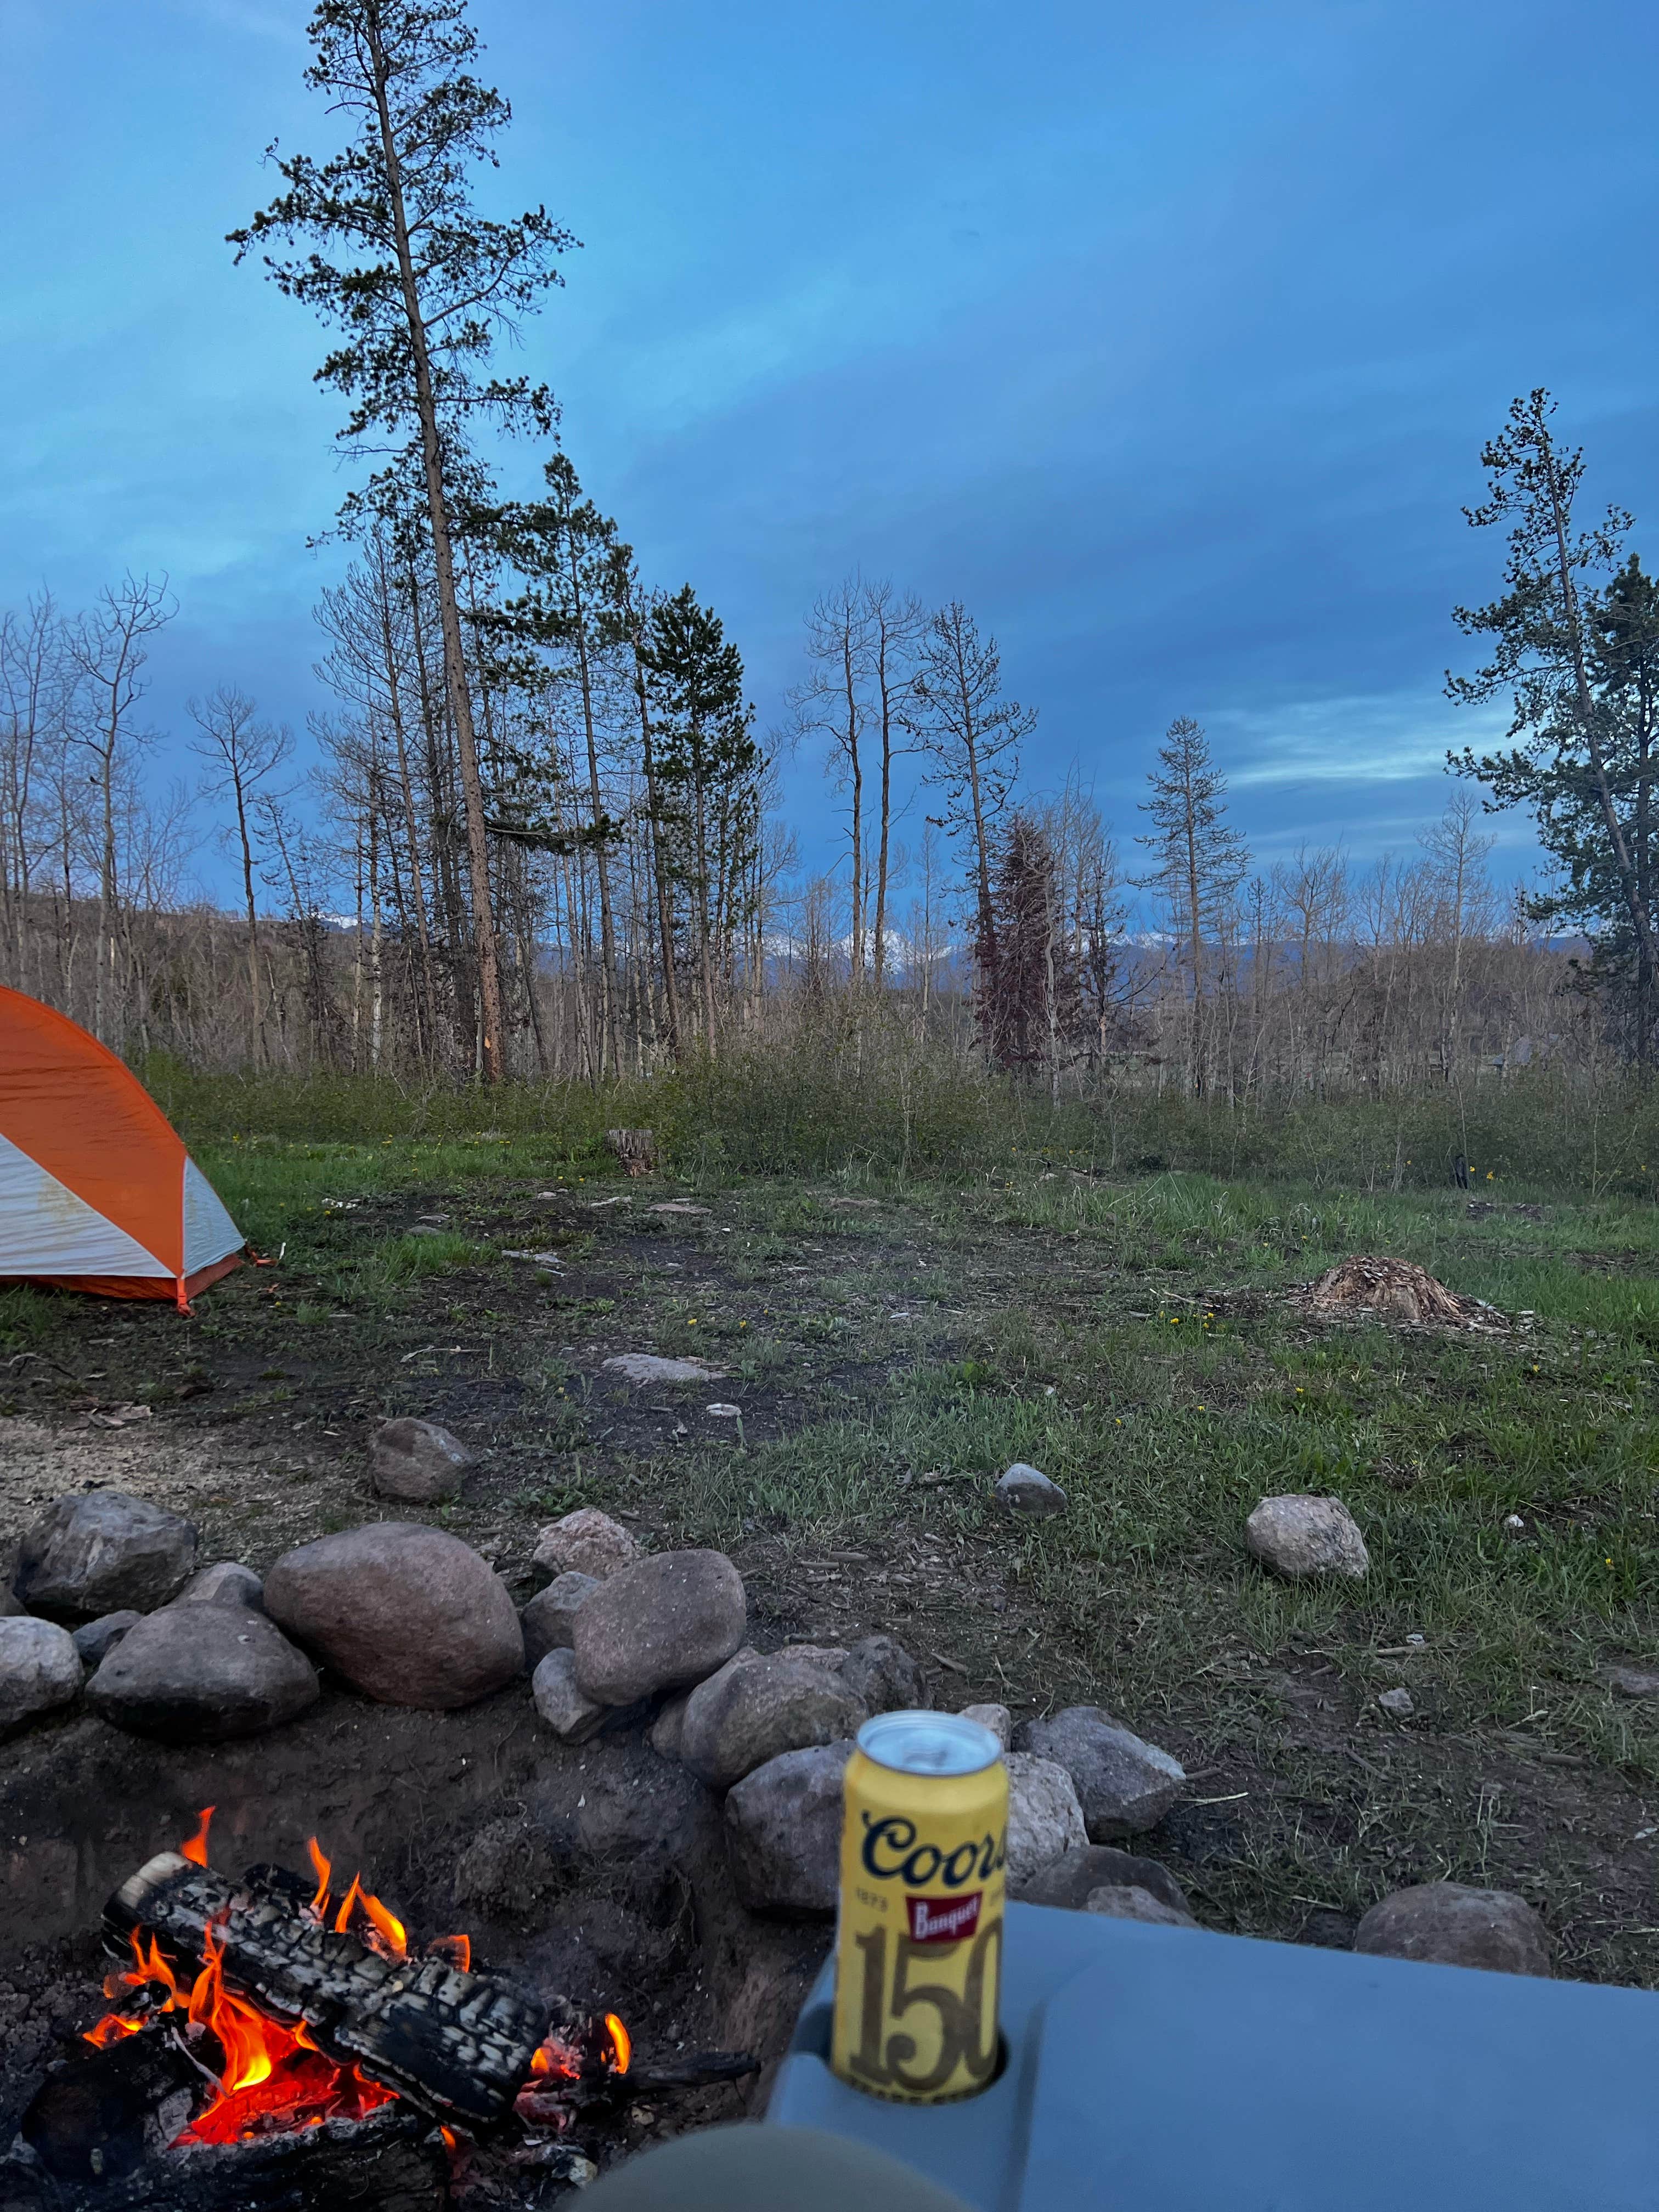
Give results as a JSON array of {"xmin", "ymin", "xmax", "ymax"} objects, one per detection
[{"xmin": 830, "ymin": 1712, "xmax": 1009, "ymax": 2103}]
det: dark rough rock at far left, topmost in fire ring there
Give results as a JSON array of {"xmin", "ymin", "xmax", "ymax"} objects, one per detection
[{"xmin": 13, "ymin": 1491, "xmax": 197, "ymax": 1626}]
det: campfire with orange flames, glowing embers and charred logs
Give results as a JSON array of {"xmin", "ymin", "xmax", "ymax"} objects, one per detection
[{"xmin": 22, "ymin": 1807, "xmax": 754, "ymax": 2212}]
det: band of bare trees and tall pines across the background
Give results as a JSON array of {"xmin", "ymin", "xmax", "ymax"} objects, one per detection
[{"xmin": 0, "ymin": 0, "xmax": 1659, "ymax": 1097}]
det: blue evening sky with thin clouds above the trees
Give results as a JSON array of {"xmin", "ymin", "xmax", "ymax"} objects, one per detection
[{"xmin": 0, "ymin": 0, "xmax": 1659, "ymax": 907}]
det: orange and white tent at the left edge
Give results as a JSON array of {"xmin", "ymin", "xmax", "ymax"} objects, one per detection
[{"xmin": 0, "ymin": 989, "xmax": 241, "ymax": 1307}]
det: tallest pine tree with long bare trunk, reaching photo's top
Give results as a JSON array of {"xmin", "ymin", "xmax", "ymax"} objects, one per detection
[{"xmin": 230, "ymin": 0, "xmax": 575, "ymax": 1082}]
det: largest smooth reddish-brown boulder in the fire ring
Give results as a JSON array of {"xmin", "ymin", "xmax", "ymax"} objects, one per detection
[{"xmin": 266, "ymin": 1522, "xmax": 524, "ymax": 1712}]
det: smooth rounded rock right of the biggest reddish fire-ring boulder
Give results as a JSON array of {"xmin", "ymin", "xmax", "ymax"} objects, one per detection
[{"xmin": 575, "ymin": 1550, "xmax": 748, "ymax": 1706}]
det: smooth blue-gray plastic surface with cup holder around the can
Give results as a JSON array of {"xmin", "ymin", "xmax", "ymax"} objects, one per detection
[{"xmin": 768, "ymin": 1905, "xmax": 1659, "ymax": 2212}]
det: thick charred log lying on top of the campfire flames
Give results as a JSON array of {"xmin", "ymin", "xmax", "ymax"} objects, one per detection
[{"xmin": 104, "ymin": 1852, "xmax": 553, "ymax": 2126}]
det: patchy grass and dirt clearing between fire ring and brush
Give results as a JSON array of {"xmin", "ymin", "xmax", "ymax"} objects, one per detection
[{"xmin": 0, "ymin": 1170, "xmax": 1659, "ymax": 2052}]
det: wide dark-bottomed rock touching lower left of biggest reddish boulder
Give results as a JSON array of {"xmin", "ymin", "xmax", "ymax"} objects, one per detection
[{"xmin": 86, "ymin": 1604, "xmax": 317, "ymax": 1743}]
